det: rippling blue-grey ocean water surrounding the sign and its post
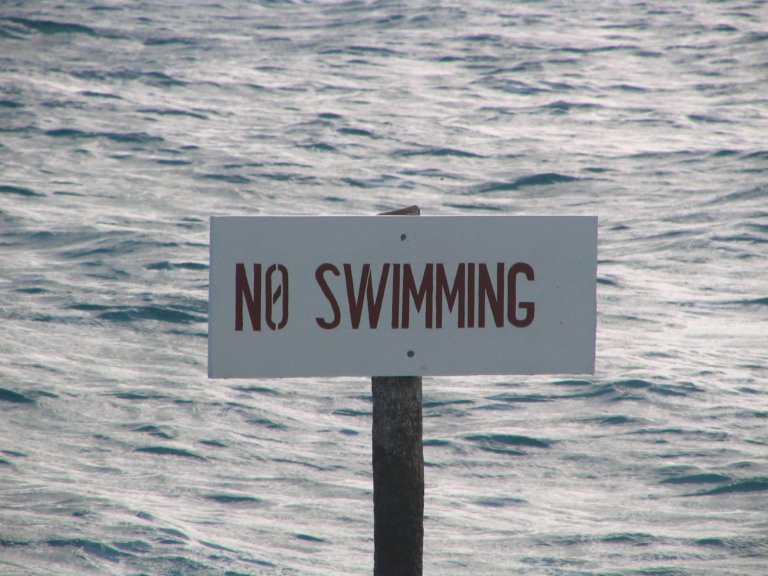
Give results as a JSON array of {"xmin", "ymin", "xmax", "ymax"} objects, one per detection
[{"xmin": 0, "ymin": 0, "xmax": 768, "ymax": 576}]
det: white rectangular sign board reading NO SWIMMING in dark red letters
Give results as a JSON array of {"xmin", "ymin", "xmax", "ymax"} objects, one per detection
[{"xmin": 208, "ymin": 216, "xmax": 597, "ymax": 378}]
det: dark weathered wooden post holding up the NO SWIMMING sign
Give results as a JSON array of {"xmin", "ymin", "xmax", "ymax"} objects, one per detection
[{"xmin": 371, "ymin": 206, "xmax": 424, "ymax": 576}]
